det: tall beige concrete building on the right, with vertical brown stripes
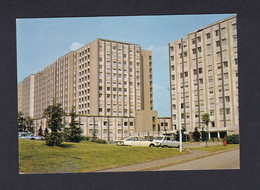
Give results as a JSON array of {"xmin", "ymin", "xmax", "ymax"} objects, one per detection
[{"xmin": 169, "ymin": 16, "xmax": 239, "ymax": 137}]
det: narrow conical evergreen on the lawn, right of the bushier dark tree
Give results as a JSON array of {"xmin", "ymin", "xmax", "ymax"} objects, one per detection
[{"xmin": 65, "ymin": 109, "xmax": 82, "ymax": 142}]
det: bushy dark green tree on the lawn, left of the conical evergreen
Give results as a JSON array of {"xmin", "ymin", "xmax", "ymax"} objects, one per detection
[{"xmin": 44, "ymin": 104, "xmax": 64, "ymax": 146}]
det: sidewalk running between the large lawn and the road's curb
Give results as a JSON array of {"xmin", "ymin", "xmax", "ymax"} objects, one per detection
[{"xmin": 96, "ymin": 146, "xmax": 238, "ymax": 172}]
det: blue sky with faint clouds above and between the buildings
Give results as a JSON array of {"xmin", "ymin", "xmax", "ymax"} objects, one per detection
[{"xmin": 16, "ymin": 14, "xmax": 234, "ymax": 117}]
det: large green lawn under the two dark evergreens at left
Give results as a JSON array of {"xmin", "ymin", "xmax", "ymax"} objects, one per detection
[{"xmin": 19, "ymin": 139, "xmax": 188, "ymax": 173}]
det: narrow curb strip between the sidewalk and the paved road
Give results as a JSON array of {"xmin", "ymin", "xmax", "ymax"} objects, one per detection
[{"xmin": 133, "ymin": 148, "xmax": 239, "ymax": 171}]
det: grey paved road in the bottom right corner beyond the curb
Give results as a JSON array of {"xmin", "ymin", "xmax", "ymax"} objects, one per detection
[{"xmin": 154, "ymin": 149, "xmax": 240, "ymax": 171}]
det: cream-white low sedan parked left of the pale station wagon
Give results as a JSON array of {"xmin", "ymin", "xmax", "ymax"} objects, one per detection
[{"xmin": 115, "ymin": 137, "xmax": 152, "ymax": 147}]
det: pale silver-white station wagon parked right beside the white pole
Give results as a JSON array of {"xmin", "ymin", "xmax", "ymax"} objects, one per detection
[{"xmin": 150, "ymin": 136, "xmax": 180, "ymax": 148}]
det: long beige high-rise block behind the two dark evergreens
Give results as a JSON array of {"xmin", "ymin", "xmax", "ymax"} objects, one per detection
[{"xmin": 18, "ymin": 39, "xmax": 158, "ymax": 141}]
